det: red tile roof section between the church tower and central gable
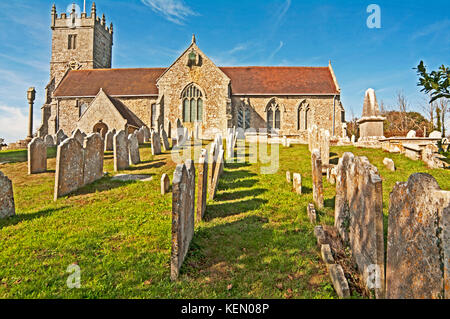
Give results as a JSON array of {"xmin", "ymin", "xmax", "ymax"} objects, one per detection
[{"xmin": 53, "ymin": 68, "xmax": 166, "ymax": 97}]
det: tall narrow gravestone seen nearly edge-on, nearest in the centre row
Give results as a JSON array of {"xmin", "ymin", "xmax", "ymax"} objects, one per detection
[{"xmin": 170, "ymin": 164, "xmax": 195, "ymax": 280}]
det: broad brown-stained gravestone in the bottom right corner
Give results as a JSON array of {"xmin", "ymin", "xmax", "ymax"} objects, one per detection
[{"xmin": 386, "ymin": 173, "xmax": 450, "ymax": 299}]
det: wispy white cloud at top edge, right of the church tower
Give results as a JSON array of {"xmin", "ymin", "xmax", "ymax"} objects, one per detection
[{"xmin": 141, "ymin": 0, "xmax": 199, "ymax": 25}]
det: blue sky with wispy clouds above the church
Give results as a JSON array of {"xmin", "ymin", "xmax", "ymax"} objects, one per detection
[{"xmin": 0, "ymin": 0, "xmax": 450, "ymax": 142}]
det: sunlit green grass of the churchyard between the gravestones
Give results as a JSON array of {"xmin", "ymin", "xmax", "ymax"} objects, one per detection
[{"xmin": 0, "ymin": 144, "xmax": 450, "ymax": 298}]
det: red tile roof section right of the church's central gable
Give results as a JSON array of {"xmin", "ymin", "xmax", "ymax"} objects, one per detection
[{"xmin": 220, "ymin": 66, "xmax": 339, "ymax": 95}]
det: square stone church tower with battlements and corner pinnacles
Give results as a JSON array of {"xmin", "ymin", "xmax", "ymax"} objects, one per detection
[{"xmin": 49, "ymin": 2, "xmax": 113, "ymax": 92}]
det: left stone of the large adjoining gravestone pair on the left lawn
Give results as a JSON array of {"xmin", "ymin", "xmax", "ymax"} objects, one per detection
[{"xmin": 54, "ymin": 137, "xmax": 84, "ymax": 201}]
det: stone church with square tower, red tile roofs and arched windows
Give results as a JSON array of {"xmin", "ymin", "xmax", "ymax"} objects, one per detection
[{"xmin": 38, "ymin": 3, "xmax": 345, "ymax": 141}]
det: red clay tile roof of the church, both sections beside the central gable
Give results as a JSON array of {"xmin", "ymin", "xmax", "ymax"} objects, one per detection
[{"xmin": 54, "ymin": 67, "xmax": 339, "ymax": 97}]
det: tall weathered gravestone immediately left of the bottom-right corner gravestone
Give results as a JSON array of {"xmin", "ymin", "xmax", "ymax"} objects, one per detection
[{"xmin": 335, "ymin": 153, "xmax": 384, "ymax": 298}]
